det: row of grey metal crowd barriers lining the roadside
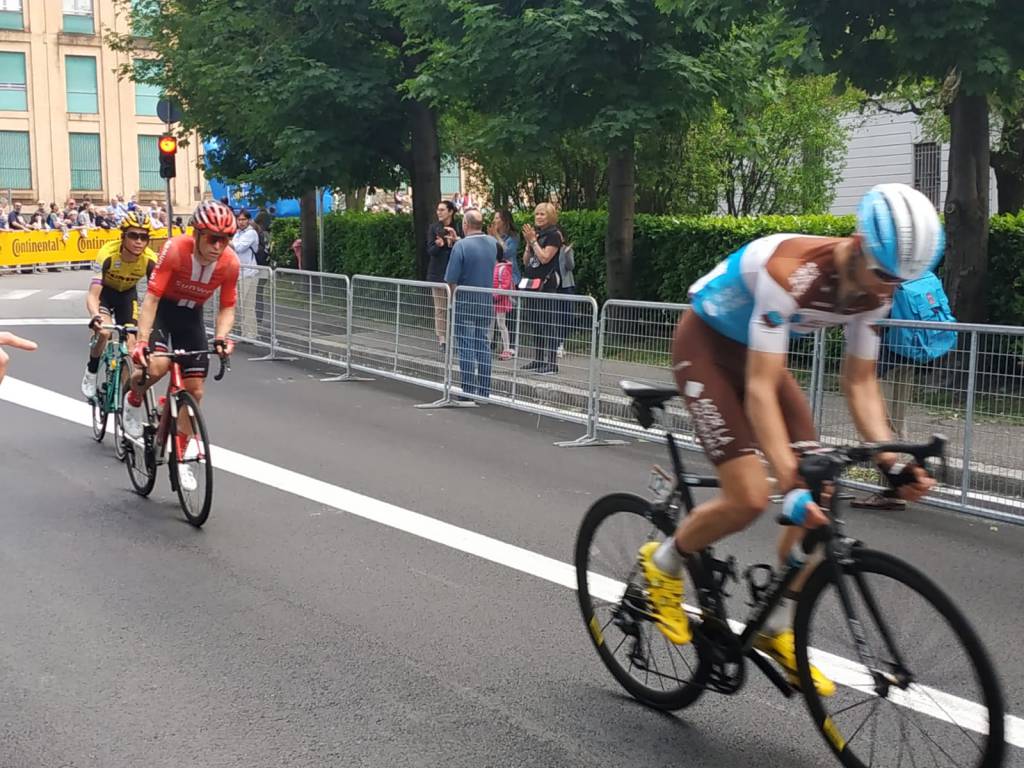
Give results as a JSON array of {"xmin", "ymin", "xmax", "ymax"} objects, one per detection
[{"xmin": 208, "ymin": 268, "xmax": 1024, "ymax": 523}]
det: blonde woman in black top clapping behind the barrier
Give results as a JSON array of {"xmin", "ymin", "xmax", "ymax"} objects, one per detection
[{"xmin": 522, "ymin": 203, "xmax": 562, "ymax": 376}]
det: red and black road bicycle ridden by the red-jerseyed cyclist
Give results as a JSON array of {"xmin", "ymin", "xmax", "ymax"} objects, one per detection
[{"xmin": 123, "ymin": 348, "xmax": 230, "ymax": 527}]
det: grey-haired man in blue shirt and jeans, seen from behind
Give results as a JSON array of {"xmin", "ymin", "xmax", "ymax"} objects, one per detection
[{"xmin": 444, "ymin": 208, "xmax": 499, "ymax": 397}]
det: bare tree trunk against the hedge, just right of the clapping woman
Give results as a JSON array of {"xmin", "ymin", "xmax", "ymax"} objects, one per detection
[{"xmin": 604, "ymin": 141, "xmax": 636, "ymax": 299}]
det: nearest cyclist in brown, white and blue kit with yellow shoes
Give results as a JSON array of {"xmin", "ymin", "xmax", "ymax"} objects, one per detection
[{"xmin": 638, "ymin": 184, "xmax": 944, "ymax": 696}]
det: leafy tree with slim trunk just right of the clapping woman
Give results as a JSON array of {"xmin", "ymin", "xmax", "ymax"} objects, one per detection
[{"xmin": 385, "ymin": 0, "xmax": 750, "ymax": 296}]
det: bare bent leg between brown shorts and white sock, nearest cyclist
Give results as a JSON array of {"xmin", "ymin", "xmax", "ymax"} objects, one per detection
[{"xmin": 676, "ymin": 454, "xmax": 771, "ymax": 553}]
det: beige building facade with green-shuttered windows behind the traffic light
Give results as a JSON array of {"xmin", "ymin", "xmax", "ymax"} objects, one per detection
[{"xmin": 0, "ymin": 0, "xmax": 207, "ymax": 210}]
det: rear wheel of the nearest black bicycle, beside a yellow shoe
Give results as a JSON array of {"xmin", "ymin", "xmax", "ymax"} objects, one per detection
[{"xmin": 575, "ymin": 494, "xmax": 708, "ymax": 710}]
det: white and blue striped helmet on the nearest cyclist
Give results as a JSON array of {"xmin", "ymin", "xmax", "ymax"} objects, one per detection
[{"xmin": 857, "ymin": 184, "xmax": 946, "ymax": 280}]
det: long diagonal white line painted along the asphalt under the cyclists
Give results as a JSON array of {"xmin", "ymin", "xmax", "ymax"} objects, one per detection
[{"xmin": 0, "ymin": 377, "xmax": 1024, "ymax": 748}]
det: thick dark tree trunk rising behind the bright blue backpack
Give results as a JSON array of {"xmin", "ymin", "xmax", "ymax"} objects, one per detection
[{"xmin": 945, "ymin": 91, "xmax": 989, "ymax": 323}]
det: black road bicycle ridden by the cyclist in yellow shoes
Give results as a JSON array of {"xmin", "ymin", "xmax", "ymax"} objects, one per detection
[{"xmin": 575, "ymin": 382, "xmax": 1006, "ymax": 768}]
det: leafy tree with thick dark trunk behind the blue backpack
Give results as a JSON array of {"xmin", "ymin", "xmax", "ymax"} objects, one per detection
[{"xmin": 774, "ymin": 0, "xmax": 1024, "ymax": 322}]
